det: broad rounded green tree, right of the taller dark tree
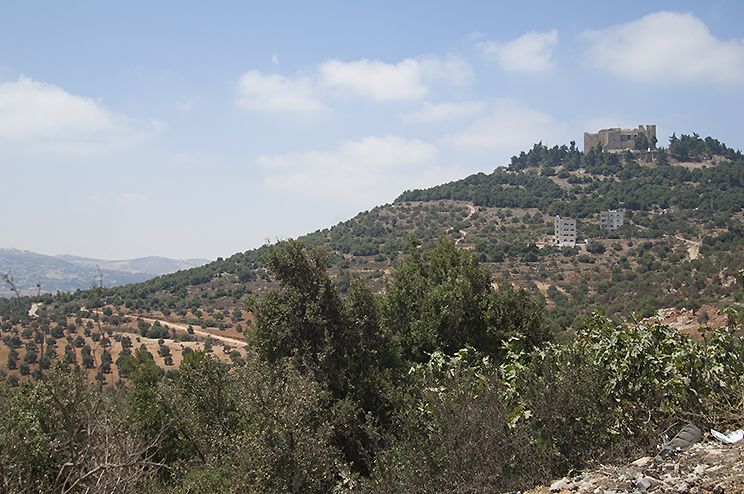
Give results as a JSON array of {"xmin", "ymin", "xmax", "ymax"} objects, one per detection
[{"xmin": 382, "ymin": 238, "xmax": 549, "ymax": 362}]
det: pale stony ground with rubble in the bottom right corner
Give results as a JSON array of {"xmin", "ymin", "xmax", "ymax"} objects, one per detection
[{"xmin": 525, "ymin": 433, "xmax": 744, "ymax": 494}]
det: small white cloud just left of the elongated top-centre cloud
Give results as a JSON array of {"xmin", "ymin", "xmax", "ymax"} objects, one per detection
[{"xmin": 237, "ymin": 70, "xmax": 330, "ymax": 114}]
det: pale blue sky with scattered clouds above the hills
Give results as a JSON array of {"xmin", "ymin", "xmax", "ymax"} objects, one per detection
[{"xmin": 0, "ymin": 0, "xmax": 744, "ymax": 260}]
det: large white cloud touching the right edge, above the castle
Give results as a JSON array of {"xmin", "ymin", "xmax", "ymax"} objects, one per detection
[{"xmin": 581, "ymin": 12, "xmax": 744, "ymax": 83}]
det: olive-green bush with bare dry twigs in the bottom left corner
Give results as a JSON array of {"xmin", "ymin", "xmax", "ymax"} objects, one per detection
[{"xmin": 0, "ymin": 365, "xmax": 159, "ymax": 492}]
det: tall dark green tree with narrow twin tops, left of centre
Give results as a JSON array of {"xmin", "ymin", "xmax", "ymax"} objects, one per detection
[{"xmin": 246, "ymin": 240, "xmax": 403, "ymax": 471}]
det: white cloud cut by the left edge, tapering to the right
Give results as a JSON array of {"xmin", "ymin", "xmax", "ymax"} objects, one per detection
[{"xmin": 0, "ymin": 76, "xmax": 163, "ymax": 156}]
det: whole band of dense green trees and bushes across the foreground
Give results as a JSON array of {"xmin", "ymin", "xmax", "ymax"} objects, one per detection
[{"xmin": 0, "ymin": 240, "xmax": 744, "ymax": 493}]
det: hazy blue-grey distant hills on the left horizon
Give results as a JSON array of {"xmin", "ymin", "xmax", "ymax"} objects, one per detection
[{"xmin": 0, "ymin": 249, "xmax": 209, "ymax": 297}]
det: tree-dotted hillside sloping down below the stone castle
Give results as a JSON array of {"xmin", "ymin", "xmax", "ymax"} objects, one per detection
[{"xmin": 45, "ymin": 131, "xmax": 744, "ymax": 329}]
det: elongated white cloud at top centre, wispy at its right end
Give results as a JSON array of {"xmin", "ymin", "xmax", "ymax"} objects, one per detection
[{"xmin": 318, "ymin": 57, "xmax": 472, "ymax": 101}]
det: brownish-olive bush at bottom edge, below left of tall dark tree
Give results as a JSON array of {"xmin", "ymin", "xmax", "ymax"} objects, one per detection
[{"xmin": 178, "ymin": 358, "xmax": 348, "ymax": 493}]
